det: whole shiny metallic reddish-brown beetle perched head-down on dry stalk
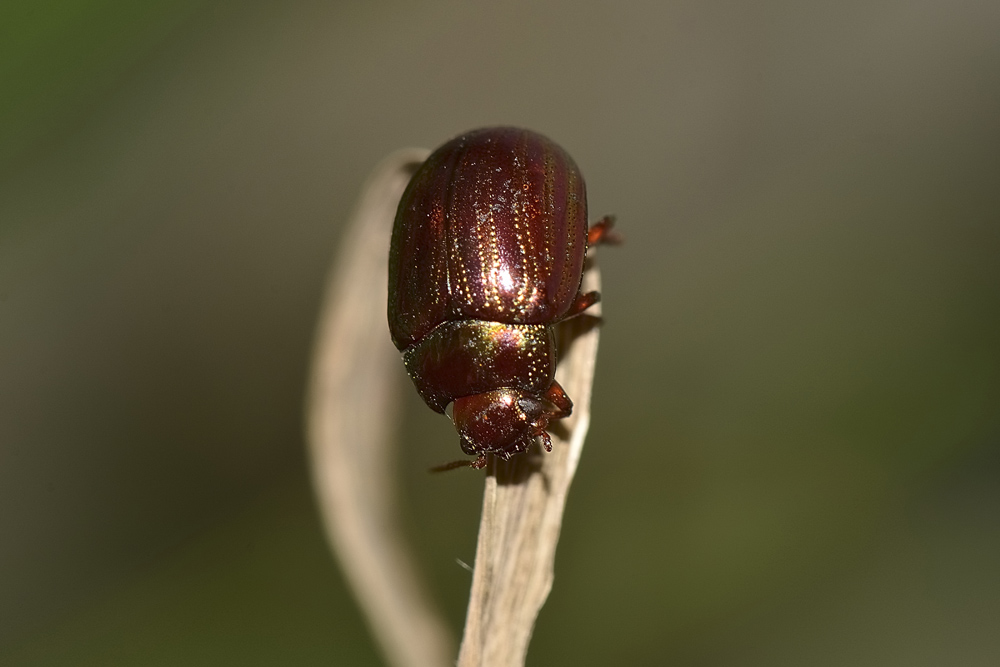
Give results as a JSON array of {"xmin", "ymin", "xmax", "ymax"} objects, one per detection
[{"xmin": 388, "ymin": 127, "xmax": 617, "ymax": 469}]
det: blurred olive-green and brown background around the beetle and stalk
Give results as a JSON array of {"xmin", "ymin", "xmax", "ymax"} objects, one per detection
[{"xmin": 0, "ymin": 0, "xmax": 1000, "ymax": 667}]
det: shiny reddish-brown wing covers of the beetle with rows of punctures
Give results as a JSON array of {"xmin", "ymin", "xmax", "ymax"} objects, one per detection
[{"xmin": 388, "ymin": 128, "xmax": 587, "ymax": 350}]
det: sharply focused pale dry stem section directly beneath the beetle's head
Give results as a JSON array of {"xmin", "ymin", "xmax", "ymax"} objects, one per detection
[{"xmin": 458, "ymin": 266, "xmax": 600, "ymax": 667}]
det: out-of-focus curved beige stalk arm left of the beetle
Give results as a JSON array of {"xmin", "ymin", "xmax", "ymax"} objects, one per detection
[{"xmin": 306, "ymin": 149, "xmax": 454, "ymax": 667}]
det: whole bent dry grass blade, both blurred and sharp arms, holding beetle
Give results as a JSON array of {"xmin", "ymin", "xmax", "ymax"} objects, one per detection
[{"xmin": 306, "ymin": 149, "xmax": 600, "ymax": 667}]
